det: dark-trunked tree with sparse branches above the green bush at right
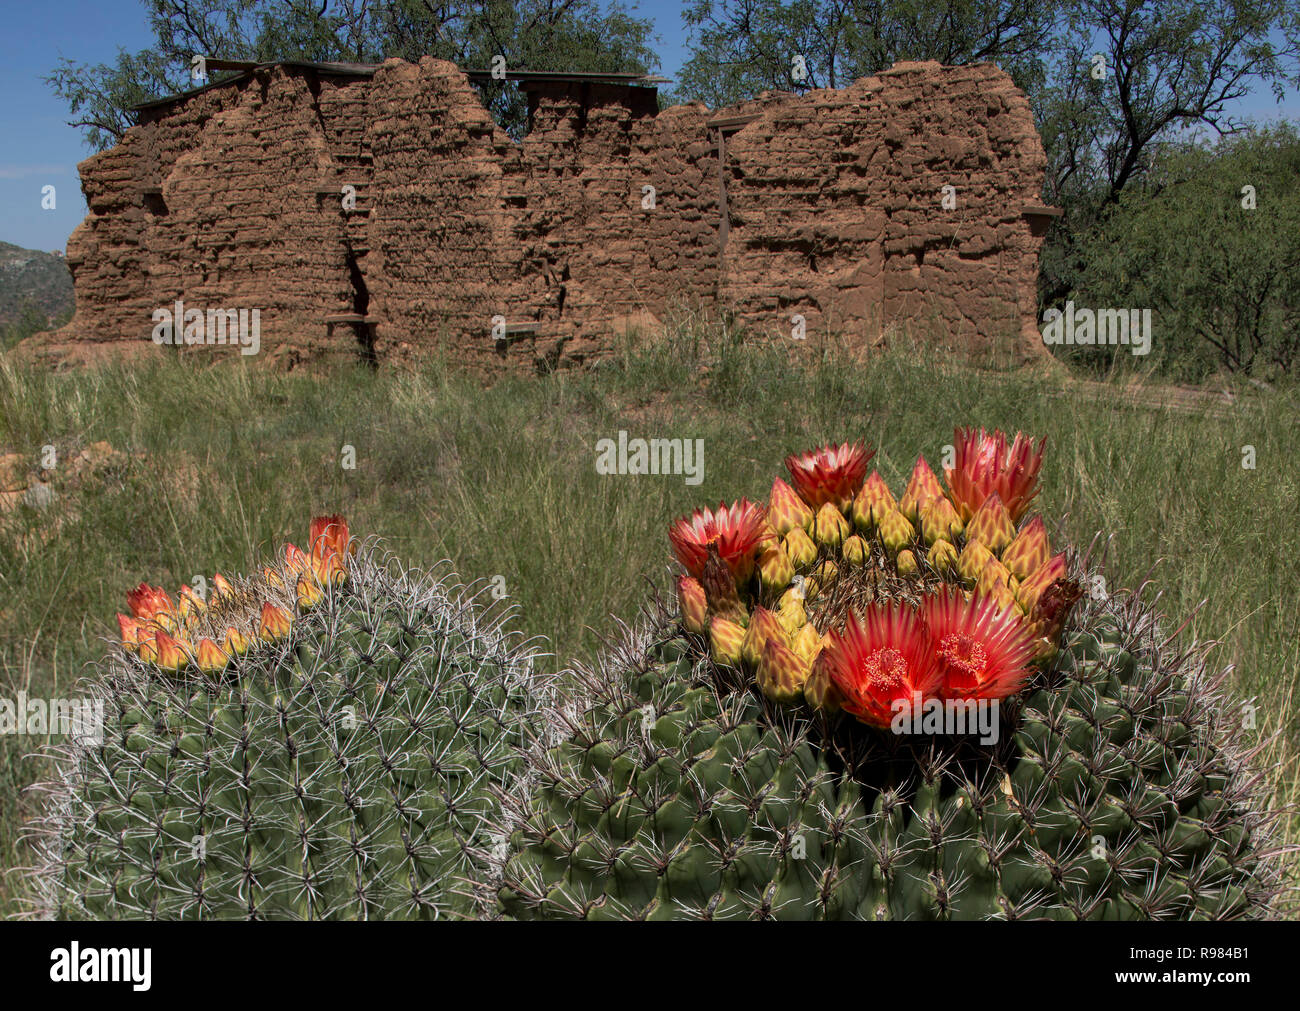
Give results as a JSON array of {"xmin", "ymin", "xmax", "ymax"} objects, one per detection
[{"xmin": 1035, "ymin": 0, "xmax": 1300, "ymax": 304}]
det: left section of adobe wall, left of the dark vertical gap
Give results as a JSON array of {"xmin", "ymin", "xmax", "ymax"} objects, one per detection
[{"xmin": 60, "ymin": 63, "xmax": 368, "ymax": 353}]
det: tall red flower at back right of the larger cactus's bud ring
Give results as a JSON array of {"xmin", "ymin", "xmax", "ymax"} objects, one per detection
[{"xmin": 944, "ymin": 429, "xmax": 1047, "ymax": 524}]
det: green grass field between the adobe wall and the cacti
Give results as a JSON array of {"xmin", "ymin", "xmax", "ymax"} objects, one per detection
[{"xmin": 0, "ymin": 329, "xmax": 1300, "ymax": 912}]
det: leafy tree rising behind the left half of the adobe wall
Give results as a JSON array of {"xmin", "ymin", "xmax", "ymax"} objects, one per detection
[{"xmin": 46, "ymin": 0, "xmax": 658, "ymax": 151}]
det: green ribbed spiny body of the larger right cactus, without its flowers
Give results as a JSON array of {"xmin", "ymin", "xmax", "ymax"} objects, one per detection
[{"xmin": 499, "ymin": 587, "xmax": 1278, "ymax": 920}]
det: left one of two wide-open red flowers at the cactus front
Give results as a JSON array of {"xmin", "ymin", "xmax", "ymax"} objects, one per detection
[{"xmin": 816, "ymin": 604, "xmax": 943, "ymax": 728}]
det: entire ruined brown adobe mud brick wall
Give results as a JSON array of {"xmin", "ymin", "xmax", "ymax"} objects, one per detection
[{"xmin": 34, "ymin": 58, "xmax": 1045, "ymax": 368}]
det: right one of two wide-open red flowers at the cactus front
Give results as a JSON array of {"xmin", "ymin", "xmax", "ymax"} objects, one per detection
[{"xmin": 920, "ymin": 589, "xmax": 1035, "ymax": 699}]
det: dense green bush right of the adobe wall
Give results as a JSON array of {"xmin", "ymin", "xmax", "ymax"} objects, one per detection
[{"xmin": 1075, "ymin": 126, "xmax": 1300, "ymax": 381}]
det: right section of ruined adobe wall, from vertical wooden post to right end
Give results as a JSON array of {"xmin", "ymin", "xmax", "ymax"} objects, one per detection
[{"xmin": 723, "ymin": 62, "xmax": 1047, "ymax": 355}]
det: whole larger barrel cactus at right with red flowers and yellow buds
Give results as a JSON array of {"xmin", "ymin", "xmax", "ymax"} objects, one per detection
[{"xmin": 499, "ymin": 430, "xmax": 1281, "ymax": 919}]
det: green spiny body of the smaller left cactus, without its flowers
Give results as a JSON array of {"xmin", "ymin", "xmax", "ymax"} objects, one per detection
[{"xmin": 29, "ymin": 551, "xmax": 545, "ymax": 919}]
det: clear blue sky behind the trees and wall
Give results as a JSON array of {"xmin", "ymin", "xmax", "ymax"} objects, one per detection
[{"xmin": 0, "ymin": 0, "xmax": 1300, "ymax": 250}]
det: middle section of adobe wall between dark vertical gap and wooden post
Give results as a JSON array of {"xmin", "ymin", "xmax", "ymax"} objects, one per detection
[{"xmin": 367, "ymin": 60, "xmax": 719, "ymax": 365}]
